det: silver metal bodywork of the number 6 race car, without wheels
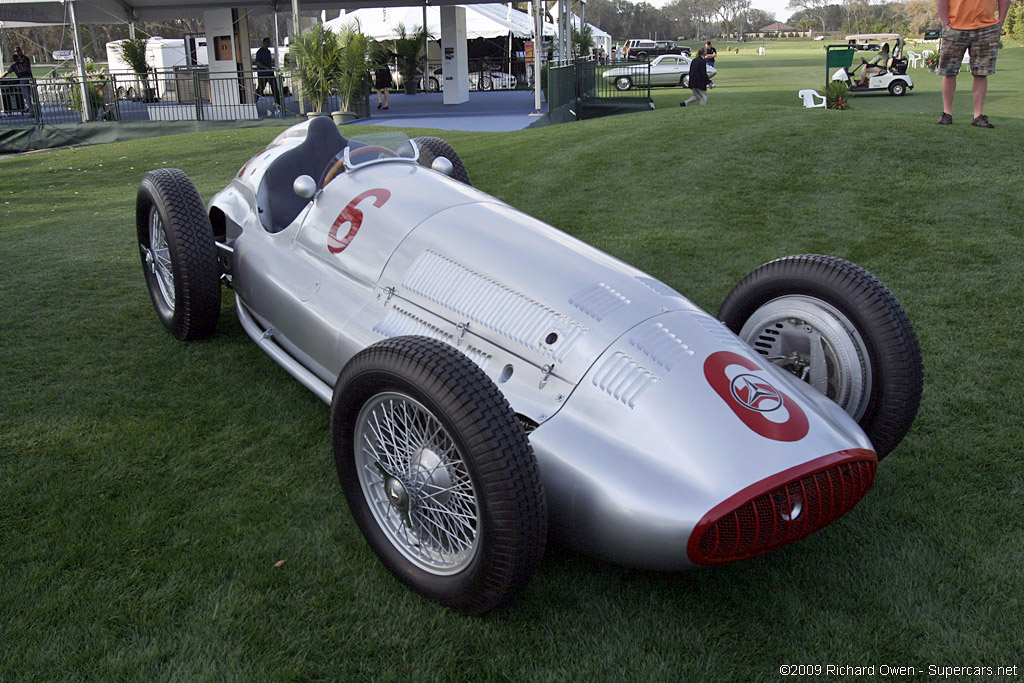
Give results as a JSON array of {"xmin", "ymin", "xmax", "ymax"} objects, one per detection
[{"xmin": 210, "ymin": 123, "xmax": 876, "ymax": 569}]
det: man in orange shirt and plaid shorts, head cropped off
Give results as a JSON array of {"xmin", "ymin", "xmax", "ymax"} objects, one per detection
[{"xmin": 936, "ymin": 0, "xmax": 1010, "ymax": 128}]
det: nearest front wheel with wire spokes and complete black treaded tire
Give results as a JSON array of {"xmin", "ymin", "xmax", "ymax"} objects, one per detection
[{"xmin": 331, "ymin": 337, "xmax": 547, "ymax": 614}]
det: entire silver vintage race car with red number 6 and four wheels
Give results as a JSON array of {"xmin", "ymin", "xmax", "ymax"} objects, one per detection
[{"xmin": 136, "ymin": 118, "xmax": 922, "ymax": 613}]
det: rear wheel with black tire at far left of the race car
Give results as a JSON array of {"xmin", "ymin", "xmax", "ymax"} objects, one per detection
[{"xmin": 135, "ymin": 168, "xmax": 220, "ymax": 341}]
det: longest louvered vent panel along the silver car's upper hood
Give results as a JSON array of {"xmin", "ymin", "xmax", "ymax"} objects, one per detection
[{"xmin": 401, "ymin": 251, "xmax": 588, "ymax": 362}]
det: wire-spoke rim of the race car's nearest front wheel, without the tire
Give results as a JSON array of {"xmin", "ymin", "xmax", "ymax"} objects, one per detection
[{"xmin": 355, "ymin": 392, "xmax": 479, "ymax": 575}]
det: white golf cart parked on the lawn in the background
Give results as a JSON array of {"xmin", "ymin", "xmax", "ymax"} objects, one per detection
[{"xmin": 825, "ymin": 33, "xmax": 913, "ymax": 96}]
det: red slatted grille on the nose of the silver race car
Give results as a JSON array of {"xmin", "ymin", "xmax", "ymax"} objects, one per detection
[{"xmin": 687, "ymin": 450, "xmax": 878, "ymax": 564}]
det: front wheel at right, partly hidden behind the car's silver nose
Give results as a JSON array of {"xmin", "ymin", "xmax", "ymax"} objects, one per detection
[{"xmin": 718, "ymin": 254, "xmax": 924, "ymax": 460}]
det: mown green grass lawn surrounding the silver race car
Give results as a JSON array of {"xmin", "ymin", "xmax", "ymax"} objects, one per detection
[{"xmin": 6, "ymin": 43, "xmax": 1024, "ymax": 681}]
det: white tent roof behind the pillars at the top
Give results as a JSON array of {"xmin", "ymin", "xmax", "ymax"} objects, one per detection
[{"xmin": 325, "ymin": 3, "xmax": 555, "ymax": 40}]
